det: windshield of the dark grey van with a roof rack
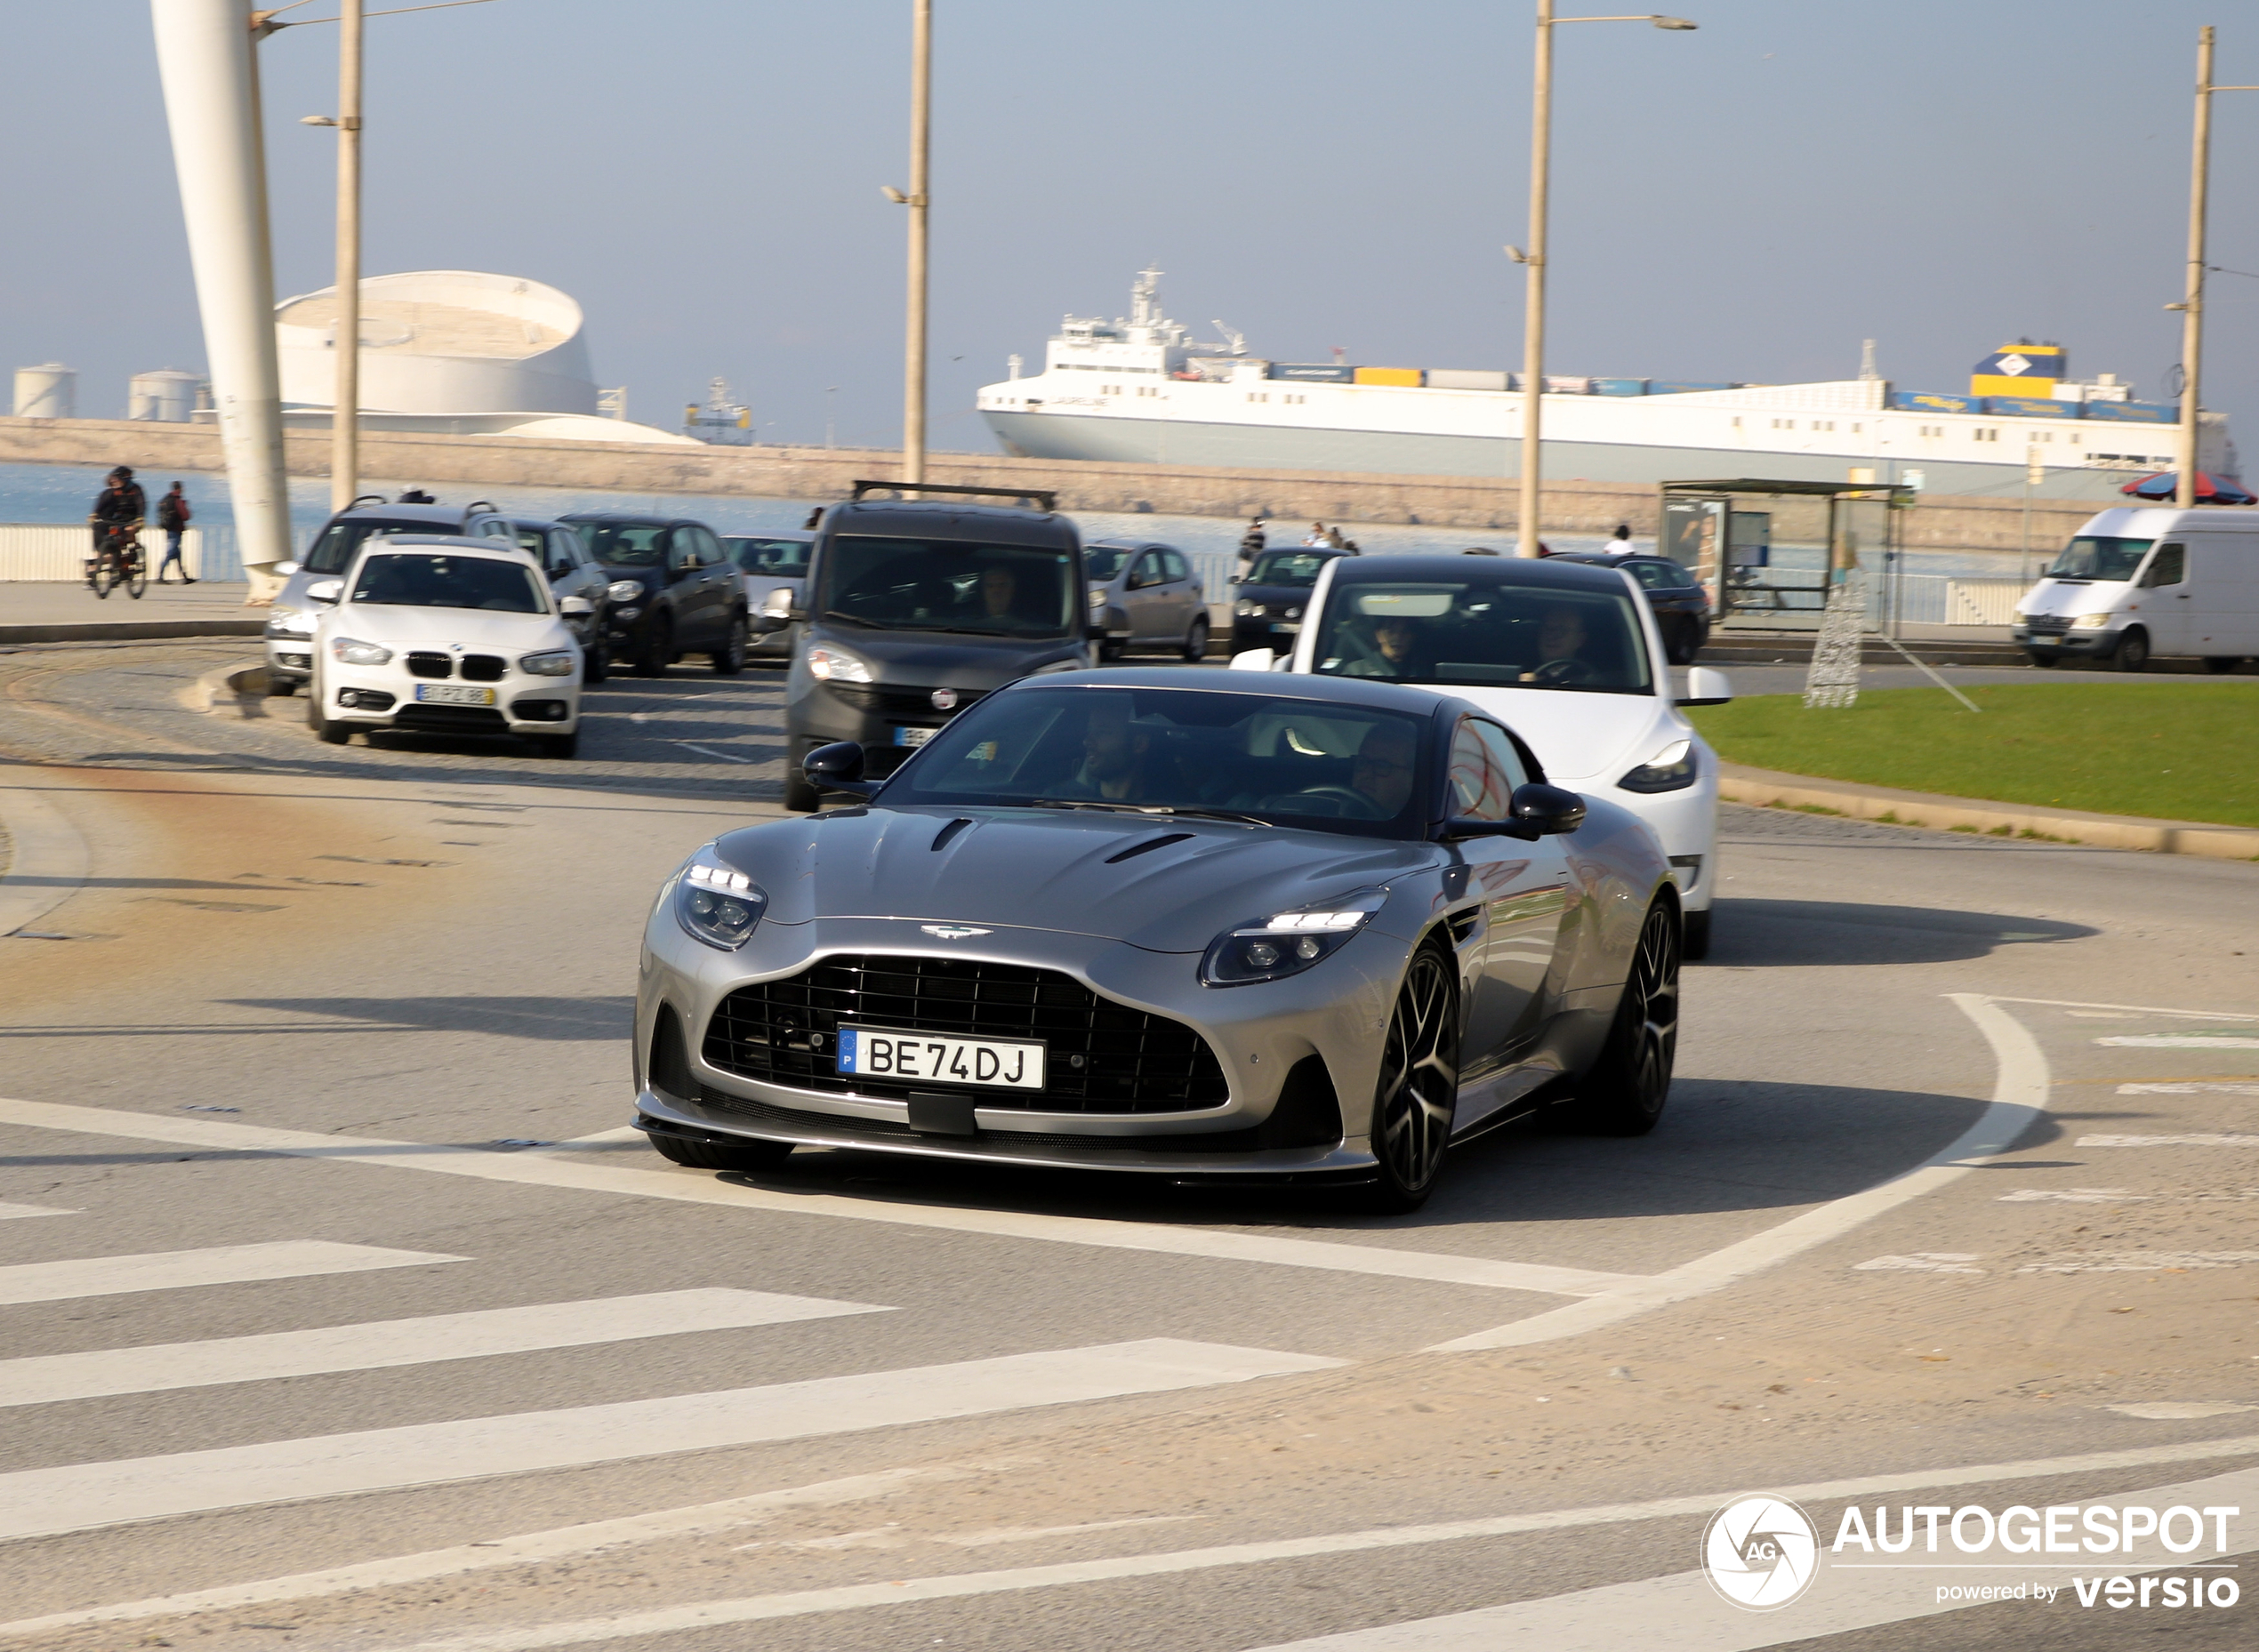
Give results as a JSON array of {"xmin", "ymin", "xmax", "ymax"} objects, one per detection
[{"xmin": 811, "ymin": 533, "xmax": 1082, "ymax": 638}]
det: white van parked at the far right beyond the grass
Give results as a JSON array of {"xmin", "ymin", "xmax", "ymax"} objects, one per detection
[{"xmin": 2015, "ymin": 506, "xmax": 2259, "ymax": 671}]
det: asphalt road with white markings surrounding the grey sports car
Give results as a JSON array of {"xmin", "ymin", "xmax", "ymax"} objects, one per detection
[{"xmin": 0, "ymin": 644, "xmax": 2259, "ymax": 1652}]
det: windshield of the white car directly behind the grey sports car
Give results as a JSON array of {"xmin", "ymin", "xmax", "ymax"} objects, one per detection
[{"xmin": 1314, "ymin": 579, "xmax": 1653, "ymax": 694}]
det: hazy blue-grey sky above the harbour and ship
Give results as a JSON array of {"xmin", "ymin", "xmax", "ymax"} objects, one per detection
[{"xmin": 0, "ymin": 0, "xmax": 2259, "ymax": 450}]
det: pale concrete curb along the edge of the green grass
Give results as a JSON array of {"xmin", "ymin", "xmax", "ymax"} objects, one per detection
[{"xmin": 1716, "ymin": 764, "xmax": 2259, "ymax": 861}]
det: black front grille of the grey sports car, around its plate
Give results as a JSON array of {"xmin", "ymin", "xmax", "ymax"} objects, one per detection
[{"xmin": 703, "ymin": 954, "xmax": 1231, "ymax": 1114}]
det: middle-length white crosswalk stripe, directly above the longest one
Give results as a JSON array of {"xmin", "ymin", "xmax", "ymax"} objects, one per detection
[{"xmin": 0, "ymin": 1288, "xmax": 888, "ymax": 1406}]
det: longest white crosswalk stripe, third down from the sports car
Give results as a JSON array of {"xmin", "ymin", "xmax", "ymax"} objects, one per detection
[{"xmin": 0, "ymin": 1338, "xmax": 1347, "ymax": 1541}]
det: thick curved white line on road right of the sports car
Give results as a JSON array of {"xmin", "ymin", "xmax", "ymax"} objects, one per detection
[{"xmin": 1430, "ymin": 992, "xmax": 2051, "ymax": 1353}]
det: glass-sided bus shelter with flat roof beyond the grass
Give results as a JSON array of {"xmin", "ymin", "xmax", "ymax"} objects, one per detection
[{"xmin": 1656, "ymin": 477, "xmax": 1916, "ymax": 630}]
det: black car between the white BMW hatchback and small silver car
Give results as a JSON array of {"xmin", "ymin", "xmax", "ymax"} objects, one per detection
[{"xmin": 562, "ymin": 510, "xmax": 750, "ymax": 678}]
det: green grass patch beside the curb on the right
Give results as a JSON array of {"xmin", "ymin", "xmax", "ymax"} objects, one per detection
[{"xmin": 1687, "ymin": 678, "xmax": 2259, "ymax": 836}]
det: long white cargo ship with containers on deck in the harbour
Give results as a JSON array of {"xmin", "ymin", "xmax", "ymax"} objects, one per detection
[{"xmin": 978, "ymin": 269, "xmax": 2241, "ymax": 500}]
